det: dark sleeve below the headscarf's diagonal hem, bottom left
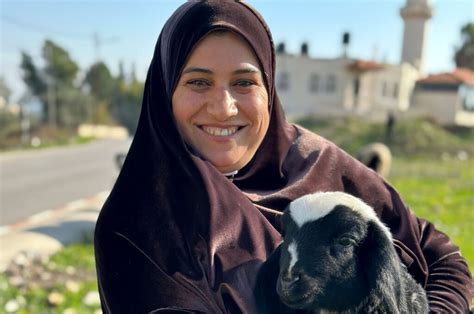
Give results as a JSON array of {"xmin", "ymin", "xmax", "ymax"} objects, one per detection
[{"xmin": 95, "ymin": 230, "xmax": 213, "ymax": 314}]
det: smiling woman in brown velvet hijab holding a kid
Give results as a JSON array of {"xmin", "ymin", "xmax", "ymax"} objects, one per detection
[{"xmin": 95, "ymin": 1, "xmax": 470, "ymax": 313}]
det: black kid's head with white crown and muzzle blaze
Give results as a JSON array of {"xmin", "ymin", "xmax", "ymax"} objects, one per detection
[{"xmin": 277, "ymin": 192, "xmax": 391, "ymax": 310}]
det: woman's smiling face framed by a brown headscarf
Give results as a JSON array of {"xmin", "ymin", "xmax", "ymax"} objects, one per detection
[{"xmin": 172, "ymin": 32, "xmax": 270, "ymax": 173}]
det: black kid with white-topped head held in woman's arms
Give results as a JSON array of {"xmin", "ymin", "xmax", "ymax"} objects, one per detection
[{"xmin": 255, "ymin": 192, "xmax": 429, "ymax": 313}]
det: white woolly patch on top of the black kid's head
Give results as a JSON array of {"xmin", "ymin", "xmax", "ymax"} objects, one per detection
[{"xmin": 289, "ymin": 192, "xmax": 392, "ymax": 240}]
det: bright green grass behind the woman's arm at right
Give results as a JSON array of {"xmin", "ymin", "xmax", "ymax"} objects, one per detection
[{"xmin": 388, "ymin": 157, "xmax": 474, "ymax": 269}]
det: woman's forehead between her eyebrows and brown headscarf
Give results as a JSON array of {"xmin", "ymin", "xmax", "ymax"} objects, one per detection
[{"xmin": 185, "ymin": 30, "xmax": 260, "ymax": 70}]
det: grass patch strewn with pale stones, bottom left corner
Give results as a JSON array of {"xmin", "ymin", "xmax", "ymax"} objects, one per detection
[{"xmin": 0, "ymin": 243, "xmax": 101, "ymax": 314}]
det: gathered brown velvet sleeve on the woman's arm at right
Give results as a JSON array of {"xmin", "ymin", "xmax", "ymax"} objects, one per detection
[{"xmin": 381, "ymin": 187, "xmax": 472, "ymax": 313}]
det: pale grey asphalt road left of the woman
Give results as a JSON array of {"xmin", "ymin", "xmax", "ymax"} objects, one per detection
[{"xmin": 0, "ymin": 140, "xmax": 131, "ymax": 226}]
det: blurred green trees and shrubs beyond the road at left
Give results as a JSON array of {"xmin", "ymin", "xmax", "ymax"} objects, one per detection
[{"xmin": 0, "ymin": 40, "xmax": 144, "ymax": 150}]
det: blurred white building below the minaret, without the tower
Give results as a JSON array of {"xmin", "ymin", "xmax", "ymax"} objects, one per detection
[{"xmin": 277, "ymin": 53, "xmax": 419, "ymax": 119}]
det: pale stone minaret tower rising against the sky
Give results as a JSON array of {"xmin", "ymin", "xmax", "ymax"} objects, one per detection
[{"xmin": 400, "ymin": 0, "xmax": 433, "ymax": 72}]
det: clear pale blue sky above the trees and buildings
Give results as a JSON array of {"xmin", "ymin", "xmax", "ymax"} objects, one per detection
[{"xmin": 0, "ymin": 0, "xmax": 474, "ymax": 101}]
